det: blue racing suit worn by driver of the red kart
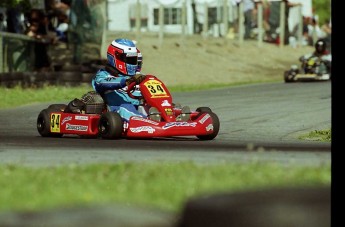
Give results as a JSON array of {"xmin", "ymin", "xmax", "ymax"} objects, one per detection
[{"xmin": 91, "ymin": 69, "xmax": 145, "ymax": 122}]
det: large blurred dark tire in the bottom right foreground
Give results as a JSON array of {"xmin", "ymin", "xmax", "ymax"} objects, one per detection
[{"xmin": 176, "ymin": 186, "xmax": 331, "ymax": 227}]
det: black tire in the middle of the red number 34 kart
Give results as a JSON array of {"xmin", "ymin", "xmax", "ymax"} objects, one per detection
[{"xmin": 98, "ymin": 112, "xmax": 123, "ymax": 139}]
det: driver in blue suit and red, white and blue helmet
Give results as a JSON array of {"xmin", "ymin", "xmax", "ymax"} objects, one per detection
[{"xmin": 91, "ymin": 39, "xmax": 152, "ymax": 122}]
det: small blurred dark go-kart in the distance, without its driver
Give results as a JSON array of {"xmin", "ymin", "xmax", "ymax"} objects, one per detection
[{"xmin": 284, "ymin": 56, "xmax": 331, "ymax": 83}]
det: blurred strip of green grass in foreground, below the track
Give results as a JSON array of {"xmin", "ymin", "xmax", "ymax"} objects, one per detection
[{"xmin": 0, "ymin": 160, "xmax": 331, "ymax": 211}]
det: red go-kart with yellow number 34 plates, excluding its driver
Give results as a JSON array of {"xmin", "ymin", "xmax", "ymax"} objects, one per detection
[{"xmin": 37, "ymin": 75, "xmax": 220, "ymax": 140}]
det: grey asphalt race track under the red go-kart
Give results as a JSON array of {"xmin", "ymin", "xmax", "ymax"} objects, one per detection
[{"xmin": 0, "ymin": 82, "xmax": 332, "ymax": 166}]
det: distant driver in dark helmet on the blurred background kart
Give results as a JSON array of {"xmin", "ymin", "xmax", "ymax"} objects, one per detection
[{"xmin": 299, "ymin": 39, "xmax": 332, "ymax": 73}]
